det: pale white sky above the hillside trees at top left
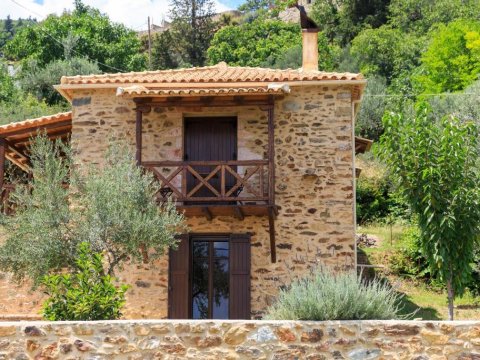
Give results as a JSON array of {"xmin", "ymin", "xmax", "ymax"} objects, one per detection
[{"xmin": 0, "ymin": 0, "xmax": 242, "ymax": 30}]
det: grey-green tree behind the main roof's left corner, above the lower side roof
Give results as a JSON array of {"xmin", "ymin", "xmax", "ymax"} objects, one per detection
[{"xmin": 19, "ymin": 57, "xmax": 100, "ymax": 105}]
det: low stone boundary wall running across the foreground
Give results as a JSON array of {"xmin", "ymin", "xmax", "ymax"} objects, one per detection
[{"xmin": 0, "ymin": 320, "xmax": 480, "ymax": 360}]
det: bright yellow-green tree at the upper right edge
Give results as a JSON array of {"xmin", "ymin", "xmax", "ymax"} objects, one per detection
[{"xmin": 416, "ymin": 20, "xmax": 480, "ymax": 93}]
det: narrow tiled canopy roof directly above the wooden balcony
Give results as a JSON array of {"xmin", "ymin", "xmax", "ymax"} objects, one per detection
[{"xmin": 117, "ymin": 85, "xmax": 290, "ymax": 96}]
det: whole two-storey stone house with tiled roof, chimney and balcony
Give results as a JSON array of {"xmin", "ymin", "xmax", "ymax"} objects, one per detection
[{"xmin": 0, "ymin": 31, "xmax": 369, "ymax": 319}]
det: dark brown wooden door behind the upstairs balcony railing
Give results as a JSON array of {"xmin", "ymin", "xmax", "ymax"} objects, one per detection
[{"xmin": 184, "ymin": 117, "xmax": 237, "ymax": 202}]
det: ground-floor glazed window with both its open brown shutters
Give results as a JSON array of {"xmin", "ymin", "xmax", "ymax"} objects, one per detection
[{"xmin": 168, "ymin": 234, "xmax": 250, "ymax": 319}]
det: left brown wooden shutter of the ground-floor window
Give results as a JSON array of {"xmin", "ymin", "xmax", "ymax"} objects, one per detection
[{"xmin": 168, "ymin": 234, "xmax": 190, "ymax": 319}]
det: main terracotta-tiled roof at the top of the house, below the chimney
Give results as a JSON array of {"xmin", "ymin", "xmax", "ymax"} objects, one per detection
[{"xmin": 60, "ymin": 63, "xmax": 364, "ymax": 87}]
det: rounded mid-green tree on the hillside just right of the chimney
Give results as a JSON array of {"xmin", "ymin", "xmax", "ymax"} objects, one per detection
[{"xmin": 351, "ymin": 26, "xmax": 424, "ymax": 84}]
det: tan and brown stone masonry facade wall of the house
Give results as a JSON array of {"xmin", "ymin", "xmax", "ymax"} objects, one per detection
[{"xmin": 0, "ymin": 86, "xmax": 355, "ymax": 319}]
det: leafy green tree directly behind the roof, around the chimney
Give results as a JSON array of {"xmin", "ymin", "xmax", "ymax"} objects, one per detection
[{"xmin": 208, "ymin": 19, "xmax": 335, "ymax": 70}]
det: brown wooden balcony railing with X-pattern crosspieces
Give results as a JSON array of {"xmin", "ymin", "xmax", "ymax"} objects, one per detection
[{"xmin": 142, "ymin": 160, "xmax": 270, "ymax": 204}]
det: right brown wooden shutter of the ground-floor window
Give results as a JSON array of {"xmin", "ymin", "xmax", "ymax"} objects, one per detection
[{"xmin": 230, "ymin": 234, "xmax": 251, "ymax": 319}]
